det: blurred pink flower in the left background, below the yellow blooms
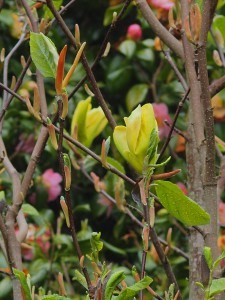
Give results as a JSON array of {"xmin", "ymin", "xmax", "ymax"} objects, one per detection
[{"xmin": 42, "ymin": 169, "xmax": 62, "ymax": 201}]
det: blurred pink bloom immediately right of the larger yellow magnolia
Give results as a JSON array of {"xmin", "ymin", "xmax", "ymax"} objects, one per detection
[{"xmin": 152, "ymin": 103, "xmax": 172, "ymax": 139}]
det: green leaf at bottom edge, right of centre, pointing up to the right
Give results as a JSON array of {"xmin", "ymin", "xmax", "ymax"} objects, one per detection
[{"xmin": 115, "ymin": 276, "xmax": 153, "ymax": 300}]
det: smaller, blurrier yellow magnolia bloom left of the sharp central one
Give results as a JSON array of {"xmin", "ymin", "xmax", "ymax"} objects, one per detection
[{"xmin": 71, "ymin": 97, "xmax": 108, "ymax": 147}]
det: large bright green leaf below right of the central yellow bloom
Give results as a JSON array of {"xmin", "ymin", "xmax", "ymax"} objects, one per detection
[{"xmin": 155, "ymin": 180, "xmax": 210, "ymax": 226}]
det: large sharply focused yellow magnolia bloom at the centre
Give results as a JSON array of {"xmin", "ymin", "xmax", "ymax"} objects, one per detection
[{"xmin": 113, "ymin": 103, "xmax": 157, "ymax": 173}]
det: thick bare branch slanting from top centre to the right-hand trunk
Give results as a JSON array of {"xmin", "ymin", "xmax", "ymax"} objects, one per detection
[{"xmin": 136, "ymin": 0, "xmax": 184, "ymax": 60}]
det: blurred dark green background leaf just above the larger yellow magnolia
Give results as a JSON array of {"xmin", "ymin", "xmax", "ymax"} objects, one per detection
[{"xmin": 126, "ymin": 84, "xmax": 149, "ymax": 112}]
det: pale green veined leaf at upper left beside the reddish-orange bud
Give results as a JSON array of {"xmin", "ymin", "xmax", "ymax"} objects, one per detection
[{"xmin": 30, "ymin": 32, "xmax": 59, "ymax": 78}]
